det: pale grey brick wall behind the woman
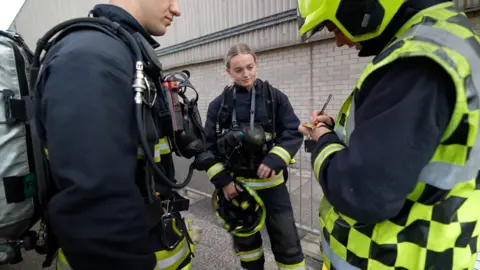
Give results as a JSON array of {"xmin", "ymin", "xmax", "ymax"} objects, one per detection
[{"xmin": 167, "ymin": 14, "xmax": 480, "ymax": 169}]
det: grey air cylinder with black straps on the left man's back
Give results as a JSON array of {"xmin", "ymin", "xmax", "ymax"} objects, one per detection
[{"xmin": 0, "ymin": 31, "xmax": 41, "ymax": 265}]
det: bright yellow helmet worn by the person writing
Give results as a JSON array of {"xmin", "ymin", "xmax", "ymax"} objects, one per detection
[{"xmin": 297, "ymin": 0, "xmax": 406, "ymax": 42}]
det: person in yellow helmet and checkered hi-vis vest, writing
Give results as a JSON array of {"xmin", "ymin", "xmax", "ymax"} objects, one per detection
[{"xmin": 298, "ymin": 0, "xmax": 480, "ymax": 270}]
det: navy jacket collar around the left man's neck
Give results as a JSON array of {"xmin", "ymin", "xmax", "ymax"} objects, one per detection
[{"xmin": 91, "ymin": 4, "xmax": 160, "ymax": 49}]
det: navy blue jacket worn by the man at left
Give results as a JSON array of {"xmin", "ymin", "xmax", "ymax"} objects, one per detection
[{"xmin": 32, "ymin": 5, "xmax": 173, "ymax": 270}]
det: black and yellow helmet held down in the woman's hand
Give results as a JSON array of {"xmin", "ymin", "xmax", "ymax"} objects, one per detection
[{"xmin": 212, "ymin": 181, "xmax": 266, "ymax": 237}]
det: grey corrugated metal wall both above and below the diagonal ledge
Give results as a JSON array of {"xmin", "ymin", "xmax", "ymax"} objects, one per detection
[{"xmin": 12, "ymin": 0, "xmax": 480, "ymax": 63}]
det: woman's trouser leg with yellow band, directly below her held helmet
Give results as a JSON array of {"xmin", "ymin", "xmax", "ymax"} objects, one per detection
[{"xmin": 233, "ymin": 232, "xmax": 265, "ymax": 270}]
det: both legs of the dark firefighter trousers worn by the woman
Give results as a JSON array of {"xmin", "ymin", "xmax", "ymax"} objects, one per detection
[{"xmin": 233, "ymin": 183, "xmax": 305, "ymax": 270}]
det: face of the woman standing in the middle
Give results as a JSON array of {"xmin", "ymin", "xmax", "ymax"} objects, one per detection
[{"xmin": 227, "ymin": 54, "xmax": 257, "ymax": 89}]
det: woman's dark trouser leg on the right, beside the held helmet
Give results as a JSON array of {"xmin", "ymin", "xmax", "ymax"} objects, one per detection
[{"xmin": 259, "ymin": 184, "xmax": 305, "ymax": 269}]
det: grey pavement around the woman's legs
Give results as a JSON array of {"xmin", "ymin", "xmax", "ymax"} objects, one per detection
[{"xmin": 0, "ymin": 156, "xmax": 321, "ymax": 270}]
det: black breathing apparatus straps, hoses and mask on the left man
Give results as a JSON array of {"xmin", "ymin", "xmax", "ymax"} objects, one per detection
[{"xmin": 0, "ymin": 17, "xmax": 214, "ymax": 267}]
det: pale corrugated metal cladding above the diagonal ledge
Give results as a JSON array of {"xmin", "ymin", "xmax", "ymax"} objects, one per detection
[{"xmin": 13, "ymin": 0, "xmax": 296, "ymax": 47}]
